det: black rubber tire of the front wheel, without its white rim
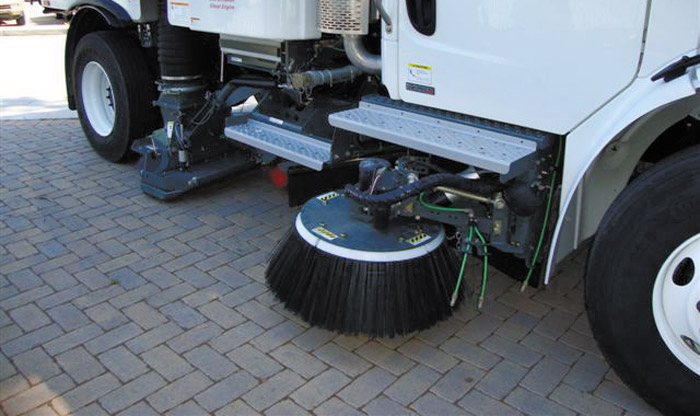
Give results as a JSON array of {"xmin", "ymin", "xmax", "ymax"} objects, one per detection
[{"xmin": 585, "ymin": 146, "xmax": 700, "ymax": 415}]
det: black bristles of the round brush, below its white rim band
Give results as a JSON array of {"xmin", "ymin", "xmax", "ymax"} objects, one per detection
[{"xmin": 266, "ymin": 227, "xmax": 463, "ymax": 337}]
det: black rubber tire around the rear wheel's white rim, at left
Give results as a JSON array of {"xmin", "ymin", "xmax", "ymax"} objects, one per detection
[{"xmin": 72, "ymin": 31, "xmax": 157, "ymax": 162}]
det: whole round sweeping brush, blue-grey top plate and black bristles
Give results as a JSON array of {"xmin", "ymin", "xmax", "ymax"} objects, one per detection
[{"xmin": 266, "ymin": 193, "xmax": 463, "ymax": 337}]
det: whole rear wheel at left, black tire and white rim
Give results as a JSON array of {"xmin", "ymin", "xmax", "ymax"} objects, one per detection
[{"xmin": 73, "ymin": 31, "xmax": 155, "ymax": 162}]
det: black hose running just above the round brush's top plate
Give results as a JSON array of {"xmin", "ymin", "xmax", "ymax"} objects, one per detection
[{"xmin": 345, "ymin": 173, "xmax": 502, "ymax": 209}]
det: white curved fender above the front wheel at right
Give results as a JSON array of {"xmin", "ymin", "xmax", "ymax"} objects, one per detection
[{"xmin": 544, "ymin": 50, "xmax": 700, "ymax": 285}]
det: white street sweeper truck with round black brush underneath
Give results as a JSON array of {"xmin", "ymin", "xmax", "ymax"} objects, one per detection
[{"xmin": 42, "ymin": 0, "xmax": 700, "ymax": 414}]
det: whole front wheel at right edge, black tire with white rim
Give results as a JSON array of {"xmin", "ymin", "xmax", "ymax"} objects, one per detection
[{"xmin": 585, "ymin": 146, "xmax": 700, "ymax": 415}]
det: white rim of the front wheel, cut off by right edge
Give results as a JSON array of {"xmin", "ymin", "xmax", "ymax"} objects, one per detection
[{"xmin": 652, "ymin": 234, "xmax": 700, "ymax": 375}]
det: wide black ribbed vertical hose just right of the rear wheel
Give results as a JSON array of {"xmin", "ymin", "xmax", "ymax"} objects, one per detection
[{"xmin": 158, "ymin": 0, "xmax": 206, "ymax": 82}]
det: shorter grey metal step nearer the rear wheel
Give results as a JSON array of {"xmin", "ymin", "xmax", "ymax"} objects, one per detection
[{"xmin": 224, "ymin": 119, "xmax": 331, "ymax": 170}]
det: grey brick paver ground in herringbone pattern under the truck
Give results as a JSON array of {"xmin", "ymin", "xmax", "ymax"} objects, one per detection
[{"xmin": 0, "ymin": 120, "xmax": 655, "ymax": 416}]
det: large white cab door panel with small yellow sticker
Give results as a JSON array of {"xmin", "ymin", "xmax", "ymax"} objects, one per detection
[{"xmin": 396, "ymin": 0, "xmax": 647, "ymax": 134}]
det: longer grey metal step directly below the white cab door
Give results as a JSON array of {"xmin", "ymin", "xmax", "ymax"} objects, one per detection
[{"xmin": 328, "ymin": 101, "xmax": 537, "ymax": 174}]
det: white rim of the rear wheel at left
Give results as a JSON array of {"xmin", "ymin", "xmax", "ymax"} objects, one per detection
[{"xmin": 81, "ymin": 62, "xmax": 115, "ymax": 137}]
